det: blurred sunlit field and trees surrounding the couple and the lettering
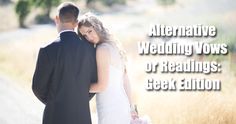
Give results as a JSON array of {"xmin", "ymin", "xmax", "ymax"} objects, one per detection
[{"xmin": 0, "ymin": 0, "xmax": 236, "ymax": 124}]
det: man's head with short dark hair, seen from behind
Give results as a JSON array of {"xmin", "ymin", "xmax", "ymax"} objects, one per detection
[{"xmin": 55, "ymin": 2, "xmax": 79, "ymax": 30}]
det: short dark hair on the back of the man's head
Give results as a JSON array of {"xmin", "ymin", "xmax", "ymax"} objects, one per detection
[{"xmin": 58, "ymin": 2, "xmax": 79, "ymax": 23}]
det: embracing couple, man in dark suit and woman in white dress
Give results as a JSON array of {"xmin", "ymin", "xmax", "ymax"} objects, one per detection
[{"xmin": 32, "ymin": 2, "xmax": 137, "ymax": 124}]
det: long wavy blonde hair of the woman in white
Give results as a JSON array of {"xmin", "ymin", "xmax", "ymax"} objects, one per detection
[{"xmin": 77, "ymin": 12, "xmax": 127, "ymax": 62}]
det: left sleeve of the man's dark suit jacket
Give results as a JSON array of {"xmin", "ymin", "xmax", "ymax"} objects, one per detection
[{"xmin": 32, "ymin": 48, "xmax": 52, "ymax": 104}]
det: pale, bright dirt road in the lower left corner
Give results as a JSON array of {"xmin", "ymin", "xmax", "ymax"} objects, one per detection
[{"xmin": 0, "ymin": 77, "xmax": 44, "ymax": 124}]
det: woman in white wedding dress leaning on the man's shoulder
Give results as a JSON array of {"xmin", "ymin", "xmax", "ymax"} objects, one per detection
[{"xmin": 78, "ymin": 13, "xmax": 137, "ymax": 124}]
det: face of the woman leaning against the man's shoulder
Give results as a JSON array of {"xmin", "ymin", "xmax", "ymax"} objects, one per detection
[{"xmin": 79, "ymin": 26, "xmax": 100, "ymax": 44}]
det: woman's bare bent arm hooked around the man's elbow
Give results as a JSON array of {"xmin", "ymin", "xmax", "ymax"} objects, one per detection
[{"xmin": 89, "ymin": 46, "xmax": 110, "ymax": 93}]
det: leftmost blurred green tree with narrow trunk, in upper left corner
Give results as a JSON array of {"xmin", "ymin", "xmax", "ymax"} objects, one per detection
[{"xmin": 15, "ymin": 0, "xmax": 30, "ymax": 28}]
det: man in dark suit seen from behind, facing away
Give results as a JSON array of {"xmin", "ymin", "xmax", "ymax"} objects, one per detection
[{"xmin": 32, "ymin": 2, "xmax": 97, "ymax": 124}]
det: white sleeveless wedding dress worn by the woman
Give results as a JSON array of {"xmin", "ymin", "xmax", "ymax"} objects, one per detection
[{"xmin": 96, "ymin": 43, "xmax": 131, "ymax": 124}]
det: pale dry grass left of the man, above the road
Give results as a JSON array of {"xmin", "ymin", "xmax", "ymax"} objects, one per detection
[{"xmin": 0, "ymin": 24, "xmax": 56, "ymax": 86}]
